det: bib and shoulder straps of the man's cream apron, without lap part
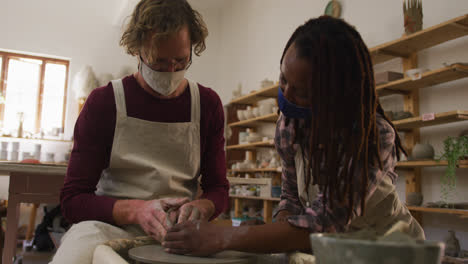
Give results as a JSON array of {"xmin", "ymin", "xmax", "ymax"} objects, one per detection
[{"xmin": 96, "ymin": 80, "xmax": 200, "ymax": 200}]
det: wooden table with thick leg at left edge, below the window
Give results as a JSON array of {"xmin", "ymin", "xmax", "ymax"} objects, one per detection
[{"xmin": 0, "ymin": 162, "xmax": 67, "ymax": 264}]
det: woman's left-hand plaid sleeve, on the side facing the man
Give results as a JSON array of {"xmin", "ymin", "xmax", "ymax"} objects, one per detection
[{"xmin": 273, "ymin": 115, "xmax": 303, "ymax": 217}]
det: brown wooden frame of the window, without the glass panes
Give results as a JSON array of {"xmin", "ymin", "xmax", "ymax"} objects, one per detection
[{"xmin": 0, "ymin": 50, "xmax": 70, "ymax": 133}]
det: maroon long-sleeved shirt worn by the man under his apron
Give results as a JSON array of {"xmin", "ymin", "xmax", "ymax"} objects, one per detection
[{"xmin": 60, "ymin": 75, "xmax": 229, "ymax": 224}]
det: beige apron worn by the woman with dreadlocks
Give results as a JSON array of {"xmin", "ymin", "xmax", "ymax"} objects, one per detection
[{"xmin": 295, "ymin": 147, "xmax": 425, "ymax": 239}]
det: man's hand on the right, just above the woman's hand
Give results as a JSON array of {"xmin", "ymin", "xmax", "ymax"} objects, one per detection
[{"xmin": 177, "ymin": 199, "xmax": 215, "ymax": 223}]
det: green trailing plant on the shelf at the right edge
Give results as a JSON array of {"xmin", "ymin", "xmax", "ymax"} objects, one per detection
[{"xmin": 439, "ymin": 136, "xmax": 468, "ymax": 202}]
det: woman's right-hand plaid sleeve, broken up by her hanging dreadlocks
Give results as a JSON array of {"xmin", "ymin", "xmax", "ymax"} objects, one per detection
[{"xmin": 288, "ymin": 114, "xmax": 397, "ymax": 233}]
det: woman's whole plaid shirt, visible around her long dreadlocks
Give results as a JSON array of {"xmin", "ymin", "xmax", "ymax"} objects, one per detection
[{"xmin": 275, "ymin": 114, "xmax": 398, "ymax": 233}]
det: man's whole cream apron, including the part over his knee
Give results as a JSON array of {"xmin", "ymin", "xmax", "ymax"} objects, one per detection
[{"xmin": 52, "ymin": 80, "xmax": 200, "ymax": 264}]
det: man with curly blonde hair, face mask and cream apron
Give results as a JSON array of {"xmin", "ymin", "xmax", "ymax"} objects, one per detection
[{"xmin": 53, "ymin": 0, "xmax": 229, "ymax": 263}]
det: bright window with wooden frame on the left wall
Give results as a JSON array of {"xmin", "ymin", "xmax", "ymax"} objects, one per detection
[{"xmin": 0, "ymin": 51, "xmax": 69, "ymax": 135}]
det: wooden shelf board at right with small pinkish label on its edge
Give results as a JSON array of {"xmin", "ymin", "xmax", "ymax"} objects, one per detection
[{"xmin": 393, "ymin": 110, "xmax": 468, "ymax": 130}]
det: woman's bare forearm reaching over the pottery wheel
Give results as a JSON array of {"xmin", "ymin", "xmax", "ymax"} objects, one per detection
[{"xmin": 223, "ymin": 222, "xmax": 310, "ymax": 253}]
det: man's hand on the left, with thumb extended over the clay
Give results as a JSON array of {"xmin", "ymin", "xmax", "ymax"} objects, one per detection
[{"xmin": 135, "ymin": 198, "xmax": 190, "ymax": 242}]
